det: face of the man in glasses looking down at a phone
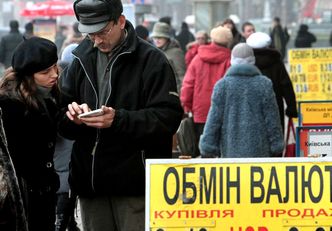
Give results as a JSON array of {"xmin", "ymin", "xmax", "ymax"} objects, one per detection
[{"xmin": 88, "ymin": 15, "xmax": 126, "ymax": 53}]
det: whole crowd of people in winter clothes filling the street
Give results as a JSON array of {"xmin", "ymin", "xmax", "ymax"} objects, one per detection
[{"xmin": 0, "ymin": 0, "xmax": 322, "ymax": 231}]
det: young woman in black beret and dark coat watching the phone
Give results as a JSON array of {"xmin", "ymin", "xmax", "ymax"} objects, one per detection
[{"xmin": 0, "ymin": 37, "xmax": 59, "ymax": 231}]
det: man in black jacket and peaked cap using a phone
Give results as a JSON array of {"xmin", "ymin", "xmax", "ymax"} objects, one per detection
[{"xmin": 59, "ymin": 0, "xmax": 183, "ymax": 231}]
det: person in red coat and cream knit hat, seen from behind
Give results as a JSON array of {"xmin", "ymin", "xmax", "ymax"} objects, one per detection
[{"xmin": 180, "ymin": 26, "xmax": 233, "ymax": 158}]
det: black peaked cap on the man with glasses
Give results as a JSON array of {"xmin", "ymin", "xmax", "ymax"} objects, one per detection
[{"xmin": 74, "ymin": 0, "xmax": 123, "ymax": 33}]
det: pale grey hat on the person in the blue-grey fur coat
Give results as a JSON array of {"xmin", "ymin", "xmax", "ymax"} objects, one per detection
[{"xmin": 231, "ymin": 43, "xmax": 256, "ymax": 65}]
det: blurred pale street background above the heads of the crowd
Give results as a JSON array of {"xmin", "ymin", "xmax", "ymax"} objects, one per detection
[{"xmin": 0, "ymin": 0, "xmax": 332, "ymax": 47}]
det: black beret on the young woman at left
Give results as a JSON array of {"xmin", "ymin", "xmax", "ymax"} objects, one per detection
[{"xmin": 12, "ymin": 37, "xmax": 58, "ymax": 75}]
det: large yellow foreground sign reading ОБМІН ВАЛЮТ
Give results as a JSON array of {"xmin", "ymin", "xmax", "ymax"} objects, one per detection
[{"xmin": 145, "ymin": 157, "xmax": 332, "ymax": 231}]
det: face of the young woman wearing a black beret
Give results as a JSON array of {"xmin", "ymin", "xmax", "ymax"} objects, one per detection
[{"xmin": 33, "ymin": 63, "xmax": 59, "ymax": 88}]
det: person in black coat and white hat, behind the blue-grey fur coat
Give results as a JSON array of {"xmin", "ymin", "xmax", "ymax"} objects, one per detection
[{"xmin": 247, "ymin": 32, "xmax": 297, "ymax": 133}]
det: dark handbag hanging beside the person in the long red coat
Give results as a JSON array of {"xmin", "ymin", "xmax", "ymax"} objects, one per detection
[{"xmin": 176, "ymin": 117, "xmax": 199, "ymax": 157}]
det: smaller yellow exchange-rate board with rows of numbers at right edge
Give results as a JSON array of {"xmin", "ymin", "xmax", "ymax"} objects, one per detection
[{"xmin": 288, "ymin": 47, "xmax": 332, "ymax": 101}]
